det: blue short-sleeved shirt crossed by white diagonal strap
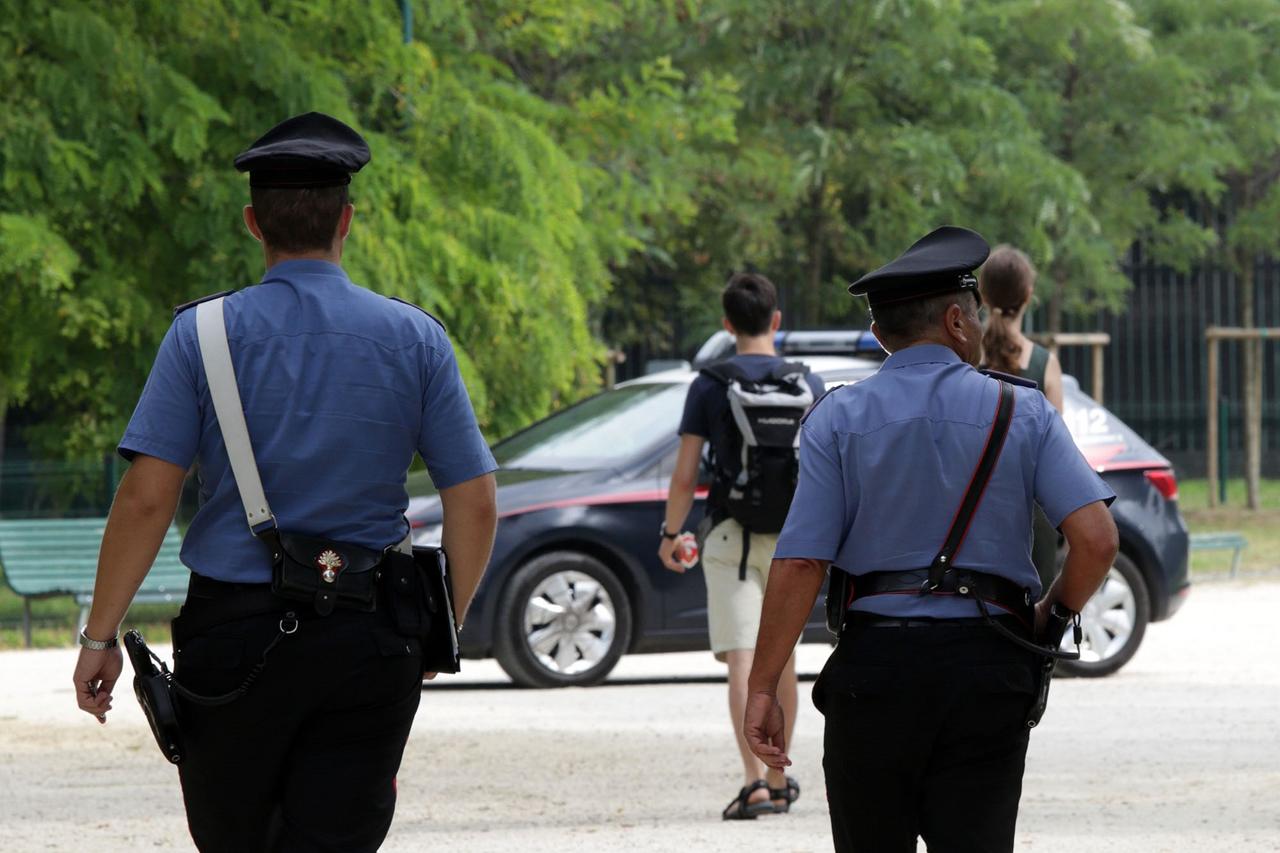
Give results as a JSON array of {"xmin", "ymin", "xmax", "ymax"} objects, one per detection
[{"xmin": 119, "ymin": 260, "xmax": 497, "ymax": 583}]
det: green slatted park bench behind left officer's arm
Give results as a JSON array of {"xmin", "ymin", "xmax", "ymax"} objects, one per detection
[{"xmin": 0, "ymin": 519, "xmax": 191, "ymax": 647}]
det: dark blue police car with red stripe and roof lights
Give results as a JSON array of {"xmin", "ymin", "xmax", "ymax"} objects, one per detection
[{"xmin": 410, "ymin": 333, "xmax": 1188, "ymax": 686}]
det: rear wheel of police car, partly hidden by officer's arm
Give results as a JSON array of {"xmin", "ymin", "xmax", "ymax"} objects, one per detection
[{"xmin": 1057, "ymin": 553, "xmax": 1151, "ymax": 678}]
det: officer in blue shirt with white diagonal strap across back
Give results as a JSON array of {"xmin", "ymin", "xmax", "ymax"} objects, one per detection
[{"xmin": 74, "ymin": 113, "xmax": 497, "ymax": 852}]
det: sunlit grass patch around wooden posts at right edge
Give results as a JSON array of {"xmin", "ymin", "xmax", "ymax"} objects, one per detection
[{"xmin": 1178, "ymin": 479, "xmax": 1280, "ymax": 574}]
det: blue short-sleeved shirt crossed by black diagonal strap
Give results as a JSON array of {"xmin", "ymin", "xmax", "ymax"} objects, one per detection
[{"xmin": 774, "ymin": 345, "xmax": 1115, "ymax": 617}]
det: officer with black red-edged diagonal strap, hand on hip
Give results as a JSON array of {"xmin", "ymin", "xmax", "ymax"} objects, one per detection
[{"xmin": 745, "ymin": 227, "xmax": 1117, "ymax": 853}]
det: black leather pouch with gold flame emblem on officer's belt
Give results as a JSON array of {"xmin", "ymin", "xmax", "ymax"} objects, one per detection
[{"xmin": 260, "ymin": 529, "xmax": 384, "ymax": 616}]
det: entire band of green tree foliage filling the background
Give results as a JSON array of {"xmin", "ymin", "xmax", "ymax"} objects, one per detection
[{"xmin": 0, "ymin": 0, "xmax": 1280, "ymax": 468}]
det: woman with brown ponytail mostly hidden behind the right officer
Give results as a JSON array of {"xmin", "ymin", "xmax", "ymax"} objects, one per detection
[{"xmin": 978, "ymin": 246, "xmax": 1062, "ymax": 589}]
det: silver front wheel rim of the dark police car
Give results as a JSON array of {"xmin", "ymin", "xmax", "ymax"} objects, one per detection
[{"xmin": 524, "ymin": 570, "xmax": 617, "ymax": 675}]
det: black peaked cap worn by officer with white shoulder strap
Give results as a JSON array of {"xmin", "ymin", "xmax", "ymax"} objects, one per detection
[{"xmin": 236, "ymin": 113, "xmax": 369, "ymax": 190}]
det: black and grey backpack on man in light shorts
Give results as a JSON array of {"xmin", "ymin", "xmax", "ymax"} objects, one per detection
[{"xmin": 701, "ymin": 361, "xmax": 814, "ymax": 578}]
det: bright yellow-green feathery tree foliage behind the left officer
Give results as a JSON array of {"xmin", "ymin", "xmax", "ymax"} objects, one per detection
[{"xmin": 0, "ymin": 0, "xmax": 735, "ymax": 453}]
